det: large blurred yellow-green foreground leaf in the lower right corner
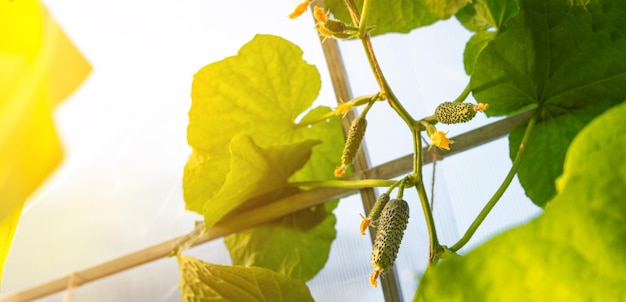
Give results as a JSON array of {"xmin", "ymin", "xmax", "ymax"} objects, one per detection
[{"xmin": 415, "ymin": 99, "xmax": 626, "ymax": 301}]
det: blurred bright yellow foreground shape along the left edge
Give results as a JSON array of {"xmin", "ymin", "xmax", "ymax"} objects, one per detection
[{"xmin": 0, "ymin": 0, "xmax": 91, "ymax": 290}]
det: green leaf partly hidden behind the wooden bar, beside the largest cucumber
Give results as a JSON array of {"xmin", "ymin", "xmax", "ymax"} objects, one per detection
[{"xmin": 224, "ymin": 107, "xmax": 344, "ymax": 280}]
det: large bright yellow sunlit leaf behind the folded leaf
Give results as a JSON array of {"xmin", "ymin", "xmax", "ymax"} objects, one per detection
[{"xmin": 183, "ymin": 35, "xmax": 321, "ymax": 213}]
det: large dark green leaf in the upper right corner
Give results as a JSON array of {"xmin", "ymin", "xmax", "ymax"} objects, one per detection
[{"xmin": 471, "ymin": 0, "xmax": 626, "ymax": 206}]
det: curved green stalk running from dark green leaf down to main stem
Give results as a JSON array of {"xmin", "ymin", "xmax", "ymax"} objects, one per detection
[{"xmin": 450, "ymin": 114, "xmax": 537, "ymax": 252}]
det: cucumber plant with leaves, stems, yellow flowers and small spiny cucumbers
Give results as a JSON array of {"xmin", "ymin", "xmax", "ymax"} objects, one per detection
[{"xmin": 176, "ymin": 0, "xmax": 626, "ymax": 301}]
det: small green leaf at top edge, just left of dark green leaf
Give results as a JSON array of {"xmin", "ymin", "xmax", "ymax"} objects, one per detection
[{"xmin": 456, "ymin": 0, "xmax": 518, "ymax": 32}]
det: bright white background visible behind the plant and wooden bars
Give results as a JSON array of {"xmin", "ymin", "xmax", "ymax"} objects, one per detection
[{"xmin": 2, "ymin": 0, "xmax": 538, "ymax": 300}]
